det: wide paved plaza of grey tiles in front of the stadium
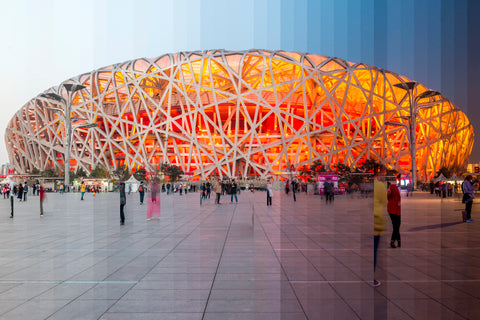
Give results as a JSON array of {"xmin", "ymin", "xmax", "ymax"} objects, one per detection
[{"xmin": 0, "ymin": 191, "xmax": 480, "ymax": 320}]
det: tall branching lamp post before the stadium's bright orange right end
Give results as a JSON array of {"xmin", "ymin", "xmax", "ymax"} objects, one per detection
[{"xmin": 385, "ymin": 81, "xmax": 441, "ymax": 190}]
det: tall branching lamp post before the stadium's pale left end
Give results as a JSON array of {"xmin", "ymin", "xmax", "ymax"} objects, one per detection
[{"xmin": 40, "ymin": 83, "xmax": 89, "ymax": 190}]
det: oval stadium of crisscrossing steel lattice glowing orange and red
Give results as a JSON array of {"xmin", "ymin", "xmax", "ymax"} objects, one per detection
[{"xmin": 5, "ymin": 50, "xmax": 473, "ymax": 178}]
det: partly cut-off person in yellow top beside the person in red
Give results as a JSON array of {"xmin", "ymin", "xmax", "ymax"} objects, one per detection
[{"xmin": 373, "ymin": 180, "xmax": 387, "ymax": 287}]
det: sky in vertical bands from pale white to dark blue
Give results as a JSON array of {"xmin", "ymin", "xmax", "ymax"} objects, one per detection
[{"xmin": 0, "ymin": 0, "xmax": 480, "ymax": 164}]
